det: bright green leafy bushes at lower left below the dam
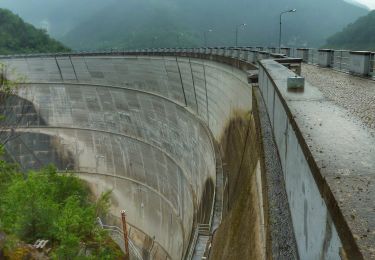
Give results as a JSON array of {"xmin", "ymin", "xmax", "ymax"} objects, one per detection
[{"xmin": 0, "ymin": 158, "xmax": 122, "ymax": 259}]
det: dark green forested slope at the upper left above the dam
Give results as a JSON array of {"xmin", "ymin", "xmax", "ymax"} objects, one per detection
[{"xmin": 0, "ymin": 9, "xmax": 69, "ymax": 54}]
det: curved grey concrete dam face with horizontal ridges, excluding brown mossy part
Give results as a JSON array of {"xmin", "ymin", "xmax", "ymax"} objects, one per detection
[{"xmin": 2, "ymin": 56, "xmax": 252, "ymax": 259}]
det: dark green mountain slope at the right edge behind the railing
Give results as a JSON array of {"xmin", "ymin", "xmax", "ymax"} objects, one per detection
[{"xmin": 325, "ymin": 11, "xmax": 375, "ymax": 51}]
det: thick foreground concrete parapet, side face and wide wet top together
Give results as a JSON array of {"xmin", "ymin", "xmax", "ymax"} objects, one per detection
[{"xmin": 260, "ymin": 61, "xmax": 375, "ymax": 259}]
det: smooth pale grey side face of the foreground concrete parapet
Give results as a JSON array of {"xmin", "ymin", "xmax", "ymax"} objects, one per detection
[{"xmin": 259, "ymin": 61, "xmax": 342, "ymax": 259}]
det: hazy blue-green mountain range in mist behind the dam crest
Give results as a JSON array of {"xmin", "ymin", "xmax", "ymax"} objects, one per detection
[{"xmin": 61, "ymin": 0, "xmax": 368, "ymax": 49}]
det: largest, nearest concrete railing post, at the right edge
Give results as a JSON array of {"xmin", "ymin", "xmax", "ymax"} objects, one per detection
[{"xmin": 349, "ymin": 51, "xmax": 371, "ymax": 76}]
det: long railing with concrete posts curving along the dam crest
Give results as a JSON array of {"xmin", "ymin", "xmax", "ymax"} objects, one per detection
[{"xmin": 0, "ymin": 47, "xmax": 375, "ymax": 79}]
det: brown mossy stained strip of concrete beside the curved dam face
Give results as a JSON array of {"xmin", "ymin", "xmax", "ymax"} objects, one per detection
[{"xmin": 210, "ymin": 113, "xmax": 263, "ymax": 259}]
